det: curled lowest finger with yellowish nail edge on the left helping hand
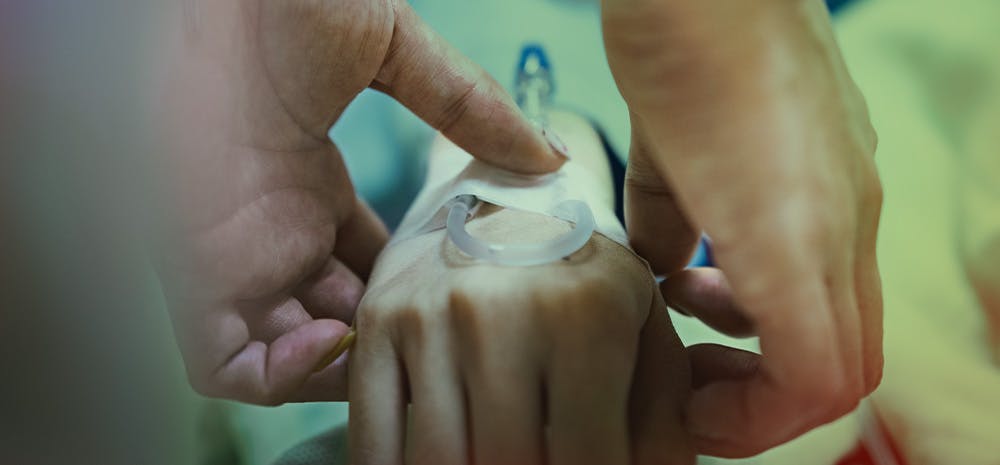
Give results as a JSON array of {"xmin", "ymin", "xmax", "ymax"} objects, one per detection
[{"xmin": 210, "ymin": 320, "xmax": 348, "ymax": 405}]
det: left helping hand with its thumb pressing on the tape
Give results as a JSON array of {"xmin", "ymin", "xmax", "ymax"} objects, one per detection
[{"xmin": 157, "ymin": 0, "xmax": 563, "ymax": 404}]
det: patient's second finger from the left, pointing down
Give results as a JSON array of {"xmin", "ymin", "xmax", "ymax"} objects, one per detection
[{"xmin": 402, "ymin": 325, "xmax": 469, "ymax": 465}]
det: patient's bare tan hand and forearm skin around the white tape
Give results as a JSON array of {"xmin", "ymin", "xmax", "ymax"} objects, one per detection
[{"xmin": 350, "ymin": 114, "xmax": 694, "ymax": 465}]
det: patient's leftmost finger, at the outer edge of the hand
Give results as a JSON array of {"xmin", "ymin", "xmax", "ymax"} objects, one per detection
[{"xmin": 348, "ymin": 319, "xmax": 406, "ymax": 465}]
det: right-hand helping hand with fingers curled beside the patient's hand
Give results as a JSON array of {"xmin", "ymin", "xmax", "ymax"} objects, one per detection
[{"xmin": 603, "ymin": 0, "xmax": 882, "ymax": 456}]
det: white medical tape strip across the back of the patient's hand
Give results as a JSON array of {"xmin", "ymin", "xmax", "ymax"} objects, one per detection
[{"xmin": 392, "ymin": 141, "xmax": 628, "ymax": 247}]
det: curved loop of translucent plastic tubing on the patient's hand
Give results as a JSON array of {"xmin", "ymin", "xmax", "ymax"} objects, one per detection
[{"xmin": 446, "ymin": 195, "xmax": 595, "ymax": 266}]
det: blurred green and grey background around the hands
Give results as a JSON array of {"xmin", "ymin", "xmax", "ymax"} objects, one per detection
[{"xmin": 0, "ymin": 0, "xmax": 1000, "ymax": 465}]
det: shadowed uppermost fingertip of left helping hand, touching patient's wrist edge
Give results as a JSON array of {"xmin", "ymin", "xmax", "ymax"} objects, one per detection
[{"xmin": 333, "ymin": 197, "xmax": 389, "ymax": 281}]
